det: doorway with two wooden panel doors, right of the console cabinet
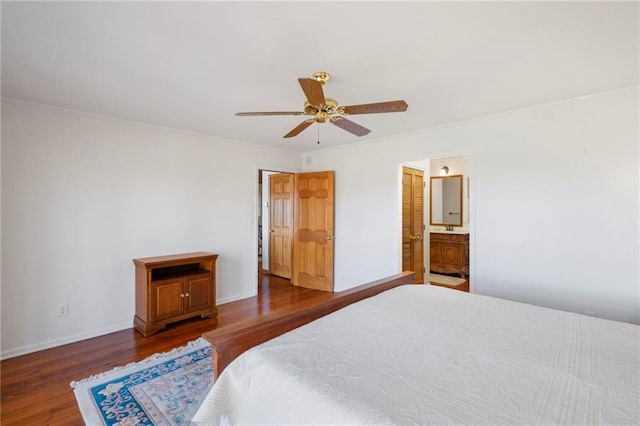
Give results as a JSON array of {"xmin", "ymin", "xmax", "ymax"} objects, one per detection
[{"xmin": 257, "ymin": 169, "xmax": 334, "ymax": 292}]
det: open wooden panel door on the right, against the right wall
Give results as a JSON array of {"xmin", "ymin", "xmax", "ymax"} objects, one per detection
[{"xmin": 292, "ymin": 171, "xmax": 334, "ymax": 292}]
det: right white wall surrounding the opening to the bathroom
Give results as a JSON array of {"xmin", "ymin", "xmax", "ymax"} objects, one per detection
[{"xmin": 305, "ymin": 87, "xmax": 640, "ymax": 323}]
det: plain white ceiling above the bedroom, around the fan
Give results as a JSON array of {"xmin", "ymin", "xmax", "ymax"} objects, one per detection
[{"xmin": 1, "ymin": 1, "xmax": 639, "ymax": 152}]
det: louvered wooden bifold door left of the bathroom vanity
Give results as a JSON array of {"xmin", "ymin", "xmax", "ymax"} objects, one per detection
[{"xmin": 402, "ymin": 167, "xmax": 425, "ymax": 283}]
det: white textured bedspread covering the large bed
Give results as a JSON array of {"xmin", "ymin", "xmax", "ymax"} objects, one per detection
[{"xmin": 194, "ymin": 285, "xmax": 640, "ymax": 425}]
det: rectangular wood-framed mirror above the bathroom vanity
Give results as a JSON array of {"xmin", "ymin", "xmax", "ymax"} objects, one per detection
[{"xmin": 429, "ymin": 175, "xmax": 462, "ymax": 226}]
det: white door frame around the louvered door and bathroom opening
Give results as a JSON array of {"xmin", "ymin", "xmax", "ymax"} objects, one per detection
[{"xmin": 396, "ymin": 149, "xmax": 477, "ymax": 293}]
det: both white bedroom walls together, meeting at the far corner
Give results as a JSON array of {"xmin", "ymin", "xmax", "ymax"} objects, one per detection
[{"xmin": 1, "ymin": 87, "xmax": 640, "ymax": 358}]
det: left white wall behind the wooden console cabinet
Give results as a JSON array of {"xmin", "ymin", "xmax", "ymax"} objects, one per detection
[{"xmin": 1, "ymin": 100, "xmax": 300, "ymax": 358}]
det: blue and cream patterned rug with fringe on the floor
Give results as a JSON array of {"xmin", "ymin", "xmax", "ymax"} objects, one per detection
[{"xmin": 71, "ymin": 338, "xmax": 213, "ymax": 426}]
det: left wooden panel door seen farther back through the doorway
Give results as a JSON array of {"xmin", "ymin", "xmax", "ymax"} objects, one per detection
[{"xmin": 269, "ymin": 174, "xmax": 294, "ymax": 279}]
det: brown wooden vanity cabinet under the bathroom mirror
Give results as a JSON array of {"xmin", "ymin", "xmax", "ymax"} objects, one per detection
[{"xmin": 429, "ymin": 232, "xmax": 469, "ymax": 278}]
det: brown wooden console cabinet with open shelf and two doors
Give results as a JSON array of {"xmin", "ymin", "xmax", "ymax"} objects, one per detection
[{"xmin": 133, "ymin": 252, "xmax": 218, "ymax": 337}]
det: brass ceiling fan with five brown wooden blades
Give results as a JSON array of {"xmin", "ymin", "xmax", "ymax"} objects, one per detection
[{"xmin": 236, "ymin": 72, "xmax": 409, "ymax": 138}]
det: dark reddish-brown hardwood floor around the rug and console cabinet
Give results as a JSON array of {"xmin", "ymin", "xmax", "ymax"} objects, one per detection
[{"xmin": 0, "ymin": 275, "xmax": 330, "ymax": 426}]
